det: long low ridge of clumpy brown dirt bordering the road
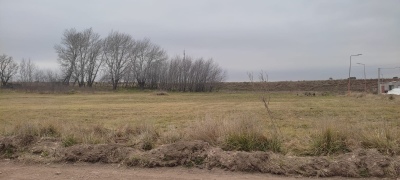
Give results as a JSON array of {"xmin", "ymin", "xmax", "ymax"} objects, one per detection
[{"xmin": 0, "ymin": 138, "xmax": 400, "ymax": 177}]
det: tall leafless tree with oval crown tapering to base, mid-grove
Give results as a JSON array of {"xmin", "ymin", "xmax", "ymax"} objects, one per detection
[{"xmin": 103, "ymin": 32, "xmax": 134, "ymax": 90}]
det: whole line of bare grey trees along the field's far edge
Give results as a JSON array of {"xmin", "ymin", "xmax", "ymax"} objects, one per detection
[{"xmin": 0, "ymin": 28, "xmax": 225, "ymax": 92}]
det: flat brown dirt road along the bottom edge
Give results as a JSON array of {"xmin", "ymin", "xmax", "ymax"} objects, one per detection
[{"xmin": 0, "ymin": 160, "xmax": 354, "ymax": 180}]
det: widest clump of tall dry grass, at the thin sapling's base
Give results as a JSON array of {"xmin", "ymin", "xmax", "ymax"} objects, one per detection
[{"xmin": 188, "ymin": 114, "xmax": 282, "ymax": 152}]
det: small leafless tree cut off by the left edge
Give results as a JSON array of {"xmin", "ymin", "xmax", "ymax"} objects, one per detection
[{"xmin": 0, "ymin": 54, "xmax": 18, "ymax": 86}]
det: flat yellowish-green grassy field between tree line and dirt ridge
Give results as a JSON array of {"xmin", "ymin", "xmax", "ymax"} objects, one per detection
[{"xmin": 0, "ymin": 90, "xmax": 400, "ymax": 155}]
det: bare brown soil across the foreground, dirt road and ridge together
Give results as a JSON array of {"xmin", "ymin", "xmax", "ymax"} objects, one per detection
[{"xmin": 0, "ymin": 137, "xmax": 400, "ymax": 179}]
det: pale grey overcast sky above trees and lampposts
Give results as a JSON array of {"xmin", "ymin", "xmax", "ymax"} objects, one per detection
[{"xmin": 0, "ymin": 0, "xmax": 400, "ymax": 81}]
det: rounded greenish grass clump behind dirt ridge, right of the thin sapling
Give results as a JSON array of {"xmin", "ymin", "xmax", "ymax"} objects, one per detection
[{"xmin": 311, "ymin": 127, "xmax": 350, "ymax": 155}]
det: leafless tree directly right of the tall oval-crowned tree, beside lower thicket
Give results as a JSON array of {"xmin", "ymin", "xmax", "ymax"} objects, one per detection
[{"xmin": 131, "ymin": 38, "xmax": 168, "ymax": 89}]
